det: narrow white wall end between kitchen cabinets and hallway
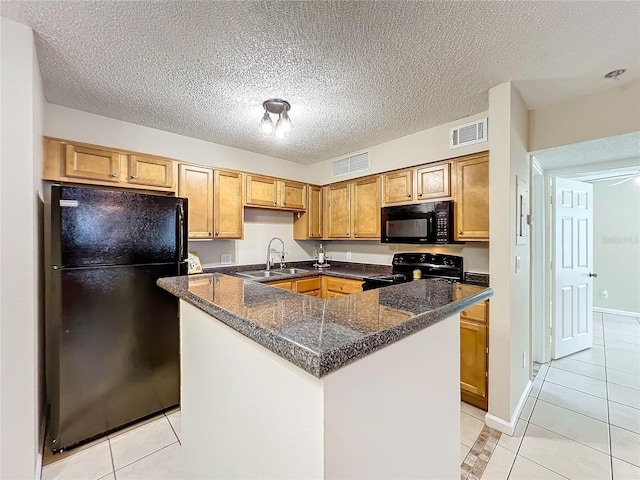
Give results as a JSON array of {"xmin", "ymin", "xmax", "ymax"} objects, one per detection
[{"xmin": 487, "ymin": 82, "xmax": 530, "ymax": 430}]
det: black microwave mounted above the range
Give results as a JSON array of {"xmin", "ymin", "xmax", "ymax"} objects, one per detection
[{"xmin": 380, "ymin": 201, "xmax": 454, "ymax": 244}]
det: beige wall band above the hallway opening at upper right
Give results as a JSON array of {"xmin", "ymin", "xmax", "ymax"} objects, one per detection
[{"xmin": 529, "ymin": 80, "xmax": 640, "ymax": 152}]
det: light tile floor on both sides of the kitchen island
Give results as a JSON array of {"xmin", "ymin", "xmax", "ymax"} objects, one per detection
[{"xmin": 42, "ymin": 313, "xmax": 640, "ymax": 480}]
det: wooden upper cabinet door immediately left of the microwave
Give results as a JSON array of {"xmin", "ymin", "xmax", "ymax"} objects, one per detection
[{"xmin": 351, "ymin": 177, "xmax": 380, "ymax": 240}]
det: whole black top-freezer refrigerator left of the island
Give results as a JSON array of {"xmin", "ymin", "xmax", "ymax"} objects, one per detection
[{"xmin": 45, "ymin": 185, "xmax": 187, "ymax": 452}]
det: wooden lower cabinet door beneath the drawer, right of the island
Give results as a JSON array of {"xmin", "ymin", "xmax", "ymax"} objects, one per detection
[{"xmin": 460, "ymin": 318, "xmax": 487, "ymax": 398}]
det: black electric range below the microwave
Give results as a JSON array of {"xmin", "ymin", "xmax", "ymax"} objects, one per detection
[{"xmin": 362, "ymin": 253, "xmax": 464, "ymax": 290}]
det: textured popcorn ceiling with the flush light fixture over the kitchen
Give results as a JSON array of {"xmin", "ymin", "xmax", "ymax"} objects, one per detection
[{"xmin": 0, "ymin": 0, "xmax": 640, "ymax": 164}]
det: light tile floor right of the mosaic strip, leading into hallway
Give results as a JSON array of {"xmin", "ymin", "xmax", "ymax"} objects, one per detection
[{"xmin": 470, "ymin": 313, "xmax": 640, "ymax": 480}]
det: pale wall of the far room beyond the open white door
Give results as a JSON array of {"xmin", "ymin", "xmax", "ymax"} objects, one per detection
[{"xmin": 593, "ymin": 179, "xmax": 640, "ymax": 315}]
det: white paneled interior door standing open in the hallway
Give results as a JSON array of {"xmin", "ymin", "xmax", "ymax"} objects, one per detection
[{"xmin": 551, "ymin": 177, "xmax": 593, "ymax": 358}]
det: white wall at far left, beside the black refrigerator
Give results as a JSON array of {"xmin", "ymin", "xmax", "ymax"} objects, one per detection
[{"xmin": 0, "ymin": 18, "xmax": 44, "ymax": 480}]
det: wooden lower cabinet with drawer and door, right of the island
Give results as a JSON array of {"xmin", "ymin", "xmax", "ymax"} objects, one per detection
[{"xmin": 460, "ymin": 302, "xmax": 489, "ymax": 411}]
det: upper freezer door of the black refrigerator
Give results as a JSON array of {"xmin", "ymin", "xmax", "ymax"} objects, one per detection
[{"xmin": 50, "ymin": 185, "xmax": 186, "ymax": 267}]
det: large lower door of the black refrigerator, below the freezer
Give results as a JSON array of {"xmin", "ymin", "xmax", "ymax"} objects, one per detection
[{"xmin": 46, "ymin": 264, "xmax": 184, "ymax": 451}]
